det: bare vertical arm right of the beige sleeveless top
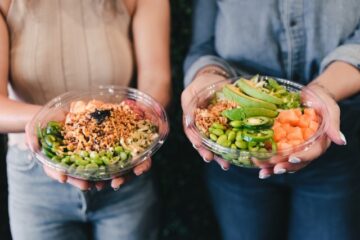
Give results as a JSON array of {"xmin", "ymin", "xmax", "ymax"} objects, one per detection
[{"xmin": 133, "ymin": 0, "xmax": 171, "ymax": 107}]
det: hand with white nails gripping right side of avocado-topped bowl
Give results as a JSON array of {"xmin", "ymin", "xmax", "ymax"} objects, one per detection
[{"xmin": 259, "ymin": 82, "xmax": 346, "ymax": 179}]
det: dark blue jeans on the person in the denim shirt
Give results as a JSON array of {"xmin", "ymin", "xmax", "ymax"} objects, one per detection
[{"xmin": 206, "ymin": 106, "xmax": 360, "ymax": 240}]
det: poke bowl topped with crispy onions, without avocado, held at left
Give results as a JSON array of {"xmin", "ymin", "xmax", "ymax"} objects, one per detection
[{"xmin": 30, "ymin": 86, "xmax": 169, "ymax": 181}]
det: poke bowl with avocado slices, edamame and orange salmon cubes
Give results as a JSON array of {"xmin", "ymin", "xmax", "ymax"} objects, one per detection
[{"xmin": 184, "ymin": 75, "xmax": 328, "ymax": 167}]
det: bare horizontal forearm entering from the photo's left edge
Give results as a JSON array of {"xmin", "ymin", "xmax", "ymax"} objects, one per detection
[{"xmin": 0, "ymin": 96, "xmax": 41, "ymax": 133}]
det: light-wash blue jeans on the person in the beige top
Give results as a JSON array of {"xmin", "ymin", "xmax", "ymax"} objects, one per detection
[{"xmin": 7, "ymin": 147, "xmax": 158, "ymax": 240}]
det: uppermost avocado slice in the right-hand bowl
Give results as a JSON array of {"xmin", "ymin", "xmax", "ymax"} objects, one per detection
[{"xmin": 236, "ymin": 78, "xmax": 283, "ymax": 105}]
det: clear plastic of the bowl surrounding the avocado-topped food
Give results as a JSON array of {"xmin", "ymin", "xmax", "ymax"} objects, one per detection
[{"xmin": 183, "ymin": 76, "xmax": 328, "ymax": 168}]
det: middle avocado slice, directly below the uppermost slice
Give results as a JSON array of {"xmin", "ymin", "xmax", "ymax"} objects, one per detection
[{"xmin": 223, "ymin": 84, "xmax": 276, "ymax": 110}]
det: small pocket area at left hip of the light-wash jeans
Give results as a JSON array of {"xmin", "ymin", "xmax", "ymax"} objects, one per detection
[{"xmin": 6, "ymin": 147, "xmax": 37, "ymax": 172}]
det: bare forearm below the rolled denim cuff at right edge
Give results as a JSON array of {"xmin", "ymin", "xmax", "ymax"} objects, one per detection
[{"xmin": 309, "ymin": 61, "xmax": 360, "ymax": 101}]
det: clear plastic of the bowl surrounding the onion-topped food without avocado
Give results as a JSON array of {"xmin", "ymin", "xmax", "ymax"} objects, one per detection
[{"xmin": 28, "ymin": 86, "xmax": 169, "ymax": 181}]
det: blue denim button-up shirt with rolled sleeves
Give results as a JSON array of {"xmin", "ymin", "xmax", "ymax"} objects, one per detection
[{"xmin": 184, "ymin": 0, "xmax": 360, "ymax": 104}]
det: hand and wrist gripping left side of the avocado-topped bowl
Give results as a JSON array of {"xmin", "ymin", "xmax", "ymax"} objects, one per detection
[{"xmin": 181, "ymin": 70, "xmax": 230, "ymax": 171}]
